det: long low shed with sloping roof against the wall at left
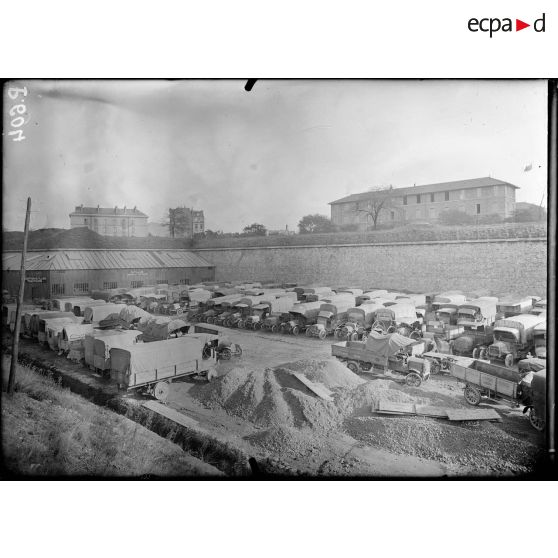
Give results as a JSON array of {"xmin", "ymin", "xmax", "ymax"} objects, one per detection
[{"xmin": 2, "ymin": 249, "xmax": 215, "ymax": 300}]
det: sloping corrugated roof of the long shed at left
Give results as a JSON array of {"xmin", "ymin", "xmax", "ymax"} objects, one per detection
[{"xmin": 2, "ymin": 250, "xmax": 215, "ymax": 271}]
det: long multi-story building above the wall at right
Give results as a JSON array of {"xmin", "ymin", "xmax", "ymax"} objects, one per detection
[{"xmin": 329, "ymin": 177, "xmax": 519, "ymax": 230}]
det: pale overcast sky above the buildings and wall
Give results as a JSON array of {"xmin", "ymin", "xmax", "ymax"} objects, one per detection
[{"xmin": 3, "ymin": 80, "xmax": 547, "ymax": 232}]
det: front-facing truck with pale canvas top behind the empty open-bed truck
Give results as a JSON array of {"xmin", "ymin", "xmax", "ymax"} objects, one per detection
[{"xmin": 488, "ymin": 314, "xmax": 541, "ymax": 368}]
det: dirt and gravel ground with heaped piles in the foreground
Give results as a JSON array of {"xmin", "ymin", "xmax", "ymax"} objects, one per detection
[{"xmin": 4, "ymin": 330, "xmax": 544, "ymax": 477}]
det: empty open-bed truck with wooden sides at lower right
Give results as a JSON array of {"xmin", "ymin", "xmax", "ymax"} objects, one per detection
[{"xmin": 450, "ymin": 359, "xmax": 540, "ymax": 414}]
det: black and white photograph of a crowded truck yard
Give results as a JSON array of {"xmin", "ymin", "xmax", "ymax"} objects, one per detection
[{"xmin": 1, "ymin": 79, "xmax": 555, "ymax": 480}]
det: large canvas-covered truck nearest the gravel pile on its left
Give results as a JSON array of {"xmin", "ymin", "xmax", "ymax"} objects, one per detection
[{"xmin": 110, "ymin": 335, "xmax": 214, "ymax": 401}]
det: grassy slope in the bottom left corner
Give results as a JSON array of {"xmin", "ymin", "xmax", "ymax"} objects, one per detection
[{"xmin": 2, "ymin": 358, "xmax": 222, "ymax": 478}]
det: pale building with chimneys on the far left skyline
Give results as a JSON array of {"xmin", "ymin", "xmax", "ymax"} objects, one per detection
[{"xmin": 70, "ymin": 205, "xmax": 147, "ymax": 236}]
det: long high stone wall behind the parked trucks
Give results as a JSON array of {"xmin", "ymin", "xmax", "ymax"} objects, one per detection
[{"xmin": 195, "ymin": 238, "xmax": 547, "ymax": 297}]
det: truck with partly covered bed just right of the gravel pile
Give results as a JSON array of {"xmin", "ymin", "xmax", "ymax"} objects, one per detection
[{"xmin": 331, "ymin": 331, "xmax": 430, "ymax": 387}]
